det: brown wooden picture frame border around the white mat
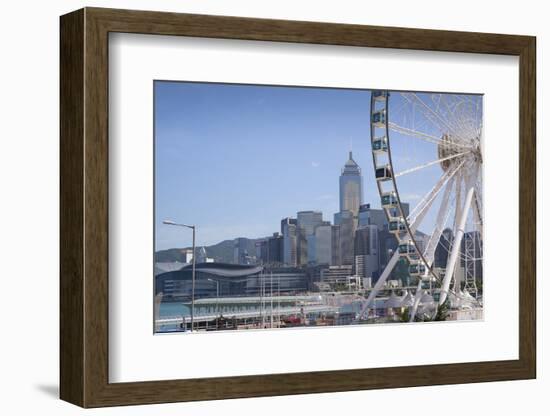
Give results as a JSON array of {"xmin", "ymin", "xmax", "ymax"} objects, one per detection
[{"xmin": 60, "ymin": 8, "xmax": 536, "ymax": 407}]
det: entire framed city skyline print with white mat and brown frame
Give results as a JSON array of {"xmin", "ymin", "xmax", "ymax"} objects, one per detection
[{"xmin": 60, "ymin": 8, "xmax": 536, "ymax": 407}]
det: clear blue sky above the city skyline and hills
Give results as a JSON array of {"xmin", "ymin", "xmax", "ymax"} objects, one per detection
[{"xmin": 155, "ymin": 81, "xmax": 484, "ymax": 250}]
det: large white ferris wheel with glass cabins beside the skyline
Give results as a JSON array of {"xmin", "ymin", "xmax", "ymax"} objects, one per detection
[{"xmin": 360, "ymin": 91, "xmax": 483, "ymax": 321}]
